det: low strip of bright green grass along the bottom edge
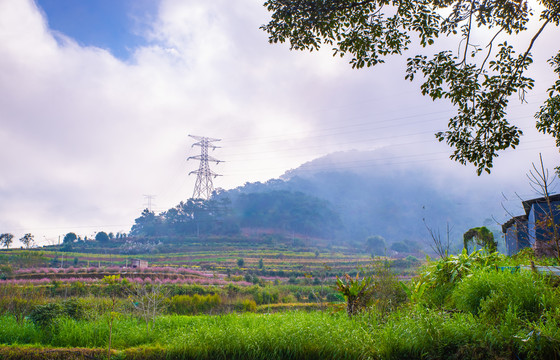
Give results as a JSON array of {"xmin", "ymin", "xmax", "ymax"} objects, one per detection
[{"xmin": 0, "ymin": 306, "xmax": 560, "ymax": 359}]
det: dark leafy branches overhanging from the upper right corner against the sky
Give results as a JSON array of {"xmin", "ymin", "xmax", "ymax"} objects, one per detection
[{"xmin": 262, "ymin": 0, "xmax": 560, "ymax": 174}]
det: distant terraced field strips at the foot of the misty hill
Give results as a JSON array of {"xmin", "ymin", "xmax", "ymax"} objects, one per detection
[{"xmin": 0, "ymin": 238, "xmax": 424, "ymax": 283}]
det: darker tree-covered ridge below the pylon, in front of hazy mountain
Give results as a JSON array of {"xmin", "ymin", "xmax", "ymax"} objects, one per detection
[{"xmin": 130, "ymin": 190, "xmax": 342, "ymax": 237}]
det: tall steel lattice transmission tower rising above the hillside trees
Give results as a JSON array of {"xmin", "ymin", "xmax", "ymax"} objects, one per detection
[{"xmin": 187, "ymin": 135, "xmax": 223, "ymax": 199}]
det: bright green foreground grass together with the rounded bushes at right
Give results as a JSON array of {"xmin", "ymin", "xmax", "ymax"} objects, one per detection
[{"xmin": 0, "ymin": 251, "xmax": 560, "ymax": 360}]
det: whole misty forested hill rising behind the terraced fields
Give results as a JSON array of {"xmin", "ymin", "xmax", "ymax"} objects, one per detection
[{"xmin": 131, "ymin": 148, "xmax": 510, "ymax": 247}]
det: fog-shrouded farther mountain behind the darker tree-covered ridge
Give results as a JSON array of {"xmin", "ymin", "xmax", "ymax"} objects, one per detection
[{"xmin": 228, "ymin": 149, "xmax": 548, "ymax": 248}]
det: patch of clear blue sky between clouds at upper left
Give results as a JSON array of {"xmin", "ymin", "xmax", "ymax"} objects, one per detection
[{"xmin": 36, "ymin": 0, "xmax": 158, "ymax": 60}]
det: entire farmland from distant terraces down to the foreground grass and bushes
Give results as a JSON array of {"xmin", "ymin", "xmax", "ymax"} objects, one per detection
[{"xmin": 0, "ymin": 240, "xmax": 560, "ymax": 359}]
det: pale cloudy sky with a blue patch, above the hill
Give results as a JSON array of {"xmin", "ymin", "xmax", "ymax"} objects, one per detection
[{"xmin": 0, "ymin": 0, "xmax": 558, "ymax": 245}]
